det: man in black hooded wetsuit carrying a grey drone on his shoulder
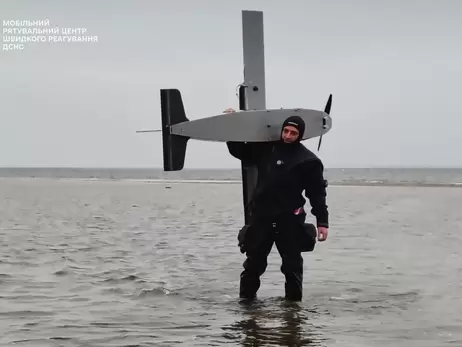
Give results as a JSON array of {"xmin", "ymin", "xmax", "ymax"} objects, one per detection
[{"xmin": 224, "ymin": 109, "xmax": 329, "ymax": 301}]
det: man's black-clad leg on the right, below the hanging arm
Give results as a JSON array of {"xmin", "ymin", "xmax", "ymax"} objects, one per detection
[{"xmin": 276, "ymin": 223, "xmax": 303, "ymax": 301}]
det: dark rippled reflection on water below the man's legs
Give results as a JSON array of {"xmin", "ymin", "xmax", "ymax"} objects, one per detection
[{"xmin": 222, "ymin": 299, "xmax": 324, "ymax": 346}]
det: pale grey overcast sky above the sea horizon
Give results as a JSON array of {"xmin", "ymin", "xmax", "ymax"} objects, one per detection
[{"xmin": 0, "ymin": 0, "xmax": 462, "ymax": 168}]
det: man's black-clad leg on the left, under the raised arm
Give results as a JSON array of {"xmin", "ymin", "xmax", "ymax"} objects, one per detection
[{"xmin": 239, "ymin": 226, "xmax": 274, "ymax": 299}]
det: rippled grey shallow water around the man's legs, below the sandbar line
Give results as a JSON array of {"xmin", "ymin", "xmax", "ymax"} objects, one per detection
[{"xmin": 0, "ymin": 178, "xmax": 462, "ymax": 347}]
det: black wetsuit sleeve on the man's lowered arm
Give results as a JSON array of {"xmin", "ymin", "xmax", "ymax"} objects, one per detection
[{"xmin": 303, "ymin": 160, "xmax": 329, "ymax": 228}]
